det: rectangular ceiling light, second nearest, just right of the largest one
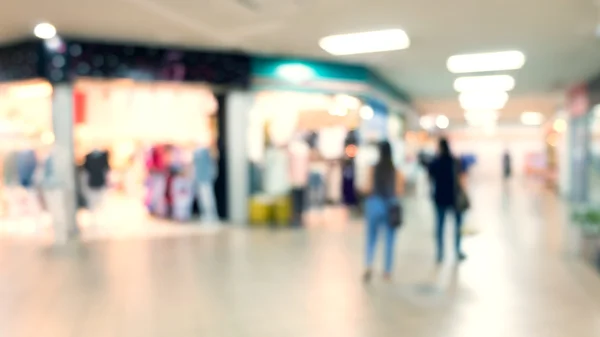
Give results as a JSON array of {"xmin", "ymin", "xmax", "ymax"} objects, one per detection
[{"xmin": 446, "ymin": 50, "xmax": 525, "ymax": 74}]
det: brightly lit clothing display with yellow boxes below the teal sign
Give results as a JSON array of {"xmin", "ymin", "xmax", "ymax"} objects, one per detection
[{"xmin": 247, "ymin": 92, "xmax": 360, "ymax": 226}]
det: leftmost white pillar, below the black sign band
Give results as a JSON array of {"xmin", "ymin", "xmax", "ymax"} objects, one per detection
[{"xmin": 52, "ymin": 84, "xmax": 78, "ymax": 244}]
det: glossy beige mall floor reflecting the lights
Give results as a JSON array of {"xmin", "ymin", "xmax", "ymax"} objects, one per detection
[{"xmin": 0, "ymin": 177, "xmax": 600, "ymax": 337}]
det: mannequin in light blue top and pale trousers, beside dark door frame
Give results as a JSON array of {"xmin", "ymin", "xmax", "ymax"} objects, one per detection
[{"xmin": 193, "ymin": 137, "xmax": 219, "ymax": 222}]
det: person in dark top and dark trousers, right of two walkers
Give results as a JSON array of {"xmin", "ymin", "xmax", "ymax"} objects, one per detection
[{"xmin": 429, "ymin": 138, "xmax": 469, "ymax": 263}]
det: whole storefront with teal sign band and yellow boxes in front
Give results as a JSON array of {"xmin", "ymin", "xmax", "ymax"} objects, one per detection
[{"xmin": 228, "ymin": 58, "xmax": 407, "ymax": 225}]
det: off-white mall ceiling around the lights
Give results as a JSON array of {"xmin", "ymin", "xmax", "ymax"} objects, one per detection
[{"xmin": 0, "ymin": 0, "xmax": 600, "ymax": 113}]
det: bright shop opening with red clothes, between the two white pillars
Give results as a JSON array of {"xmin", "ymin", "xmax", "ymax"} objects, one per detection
[{"xmin": 74, "ymin": 80, "xmax": 219, "ymax": 233}]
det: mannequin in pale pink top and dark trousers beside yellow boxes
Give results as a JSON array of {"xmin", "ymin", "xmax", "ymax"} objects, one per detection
[{"xmin": 289, "ymin": 137, "xmax": 310, "ymax": 226}]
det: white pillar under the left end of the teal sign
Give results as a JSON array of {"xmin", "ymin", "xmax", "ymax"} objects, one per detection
[{"xmin": 225, "ymin": 92, "xmax": 254, "ymax": 224}]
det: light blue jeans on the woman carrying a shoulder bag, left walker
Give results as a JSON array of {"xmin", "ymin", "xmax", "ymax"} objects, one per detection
[{"xmin": 365, "ymin": 196, "xmax": 396, "ymax": 273}]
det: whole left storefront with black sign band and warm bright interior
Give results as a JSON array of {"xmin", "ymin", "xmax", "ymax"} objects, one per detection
[{"xmin": 0, "ymin": 39, "xmax": 250, "ymax": 239}]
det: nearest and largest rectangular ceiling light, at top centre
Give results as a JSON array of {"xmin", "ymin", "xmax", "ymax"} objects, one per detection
[{"xmin": 319, "ymin": 29, "xmax": 410, "ymax": 56}]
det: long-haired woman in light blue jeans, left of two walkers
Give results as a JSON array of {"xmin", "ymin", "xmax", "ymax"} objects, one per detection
[{"xmin": 363, "ymin": 142, "xmax": 404, "ymax": 282}]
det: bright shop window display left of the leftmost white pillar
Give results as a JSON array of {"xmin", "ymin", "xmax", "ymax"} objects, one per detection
[{"xmin": 0, "ymin": 80, "xmax": 61, "ymax": 233}]
